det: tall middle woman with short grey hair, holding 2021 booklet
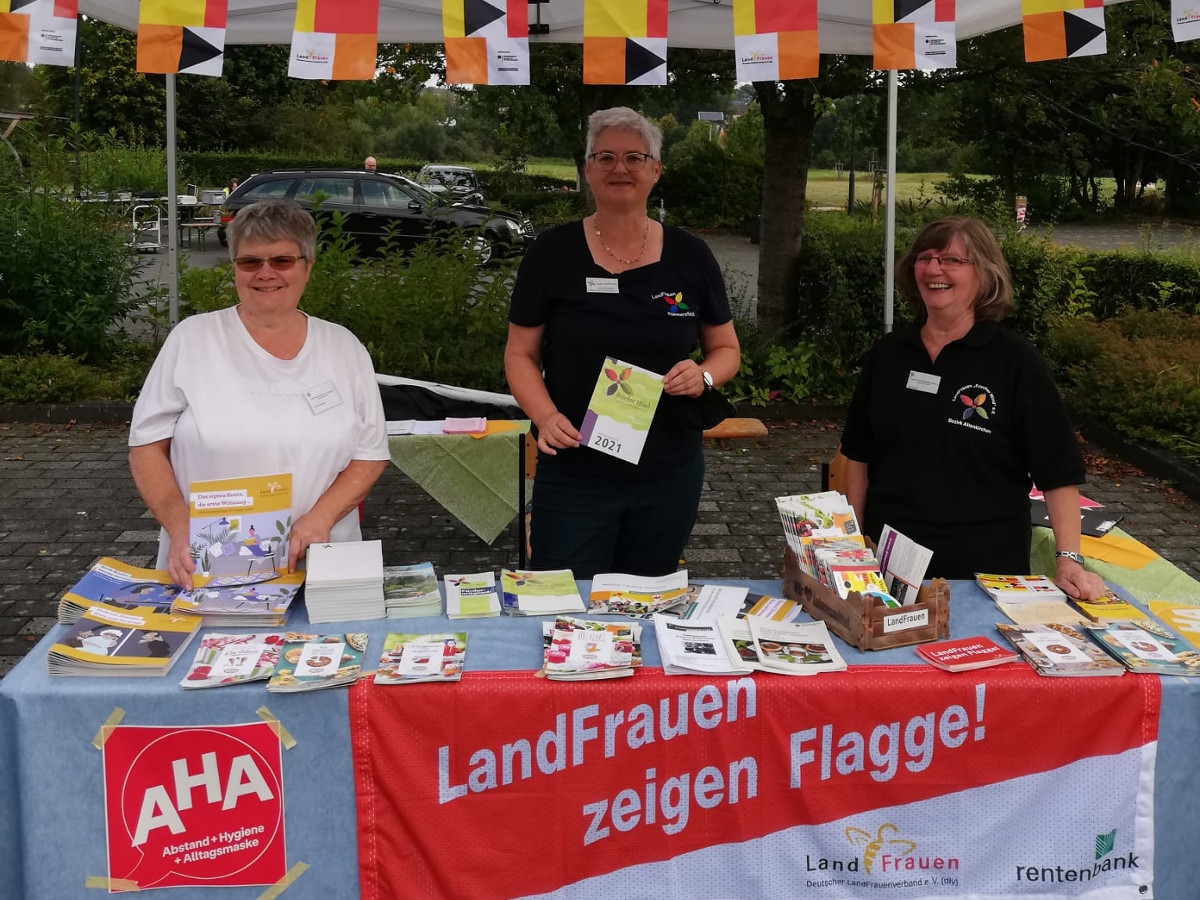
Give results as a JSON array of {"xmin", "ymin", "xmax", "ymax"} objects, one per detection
[{"xmin": 504, "ymin": 107, "xmax": 740, "ymax": 578}]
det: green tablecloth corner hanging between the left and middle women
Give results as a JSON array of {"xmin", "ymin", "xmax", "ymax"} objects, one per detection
[{"xmin": 388, "ymin": 421, "xmax": 529, "ymax": 544}]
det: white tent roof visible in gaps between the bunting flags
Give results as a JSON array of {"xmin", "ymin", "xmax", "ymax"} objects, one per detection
[{"xmin": 79, "ymin": 0, "xmax": 1120, "ymax": 55}]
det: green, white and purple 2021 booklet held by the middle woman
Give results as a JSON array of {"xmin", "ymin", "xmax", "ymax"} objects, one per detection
[{"xmin": 580, "ymin": 356, "xmax": 662, "ymax": 466}]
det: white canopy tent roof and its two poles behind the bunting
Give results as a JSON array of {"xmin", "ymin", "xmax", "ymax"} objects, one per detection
[{"xmin": 79, "ymin": 0, "xmax": 1124, "ymax": 331}]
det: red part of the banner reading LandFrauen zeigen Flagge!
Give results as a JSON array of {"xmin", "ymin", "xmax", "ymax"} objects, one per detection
[{"xmin": 350, "ymin": 664, "xmax": 1159, "ymax": 900}]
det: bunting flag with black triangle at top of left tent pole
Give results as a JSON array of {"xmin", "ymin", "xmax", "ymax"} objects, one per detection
[{"xmin": 138, "ymin": 0, "xmax": 229, "ymax": 78}]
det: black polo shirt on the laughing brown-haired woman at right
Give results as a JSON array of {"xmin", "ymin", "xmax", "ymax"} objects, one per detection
[{"xmin": 841, "ymin": 322, "xmax": 1085, "ymax": 577}]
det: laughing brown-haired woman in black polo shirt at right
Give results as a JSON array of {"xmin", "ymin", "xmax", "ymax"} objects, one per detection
[{"xmin": 841, "ymin": 216, "xmax": 1104, "ymax": 598}]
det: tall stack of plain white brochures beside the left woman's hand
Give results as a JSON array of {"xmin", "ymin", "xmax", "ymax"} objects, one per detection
[{"xmin": 305, "ymin": 541, "xmax": 386, "ymax": 625}]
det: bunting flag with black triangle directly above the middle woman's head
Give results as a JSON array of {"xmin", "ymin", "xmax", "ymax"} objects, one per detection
[{"xmin": 583, "ymin": 0, "xmax": 667, "ymax": 84}]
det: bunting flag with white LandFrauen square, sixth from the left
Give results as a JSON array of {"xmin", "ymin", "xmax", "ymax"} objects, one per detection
[{"xmin": 733, "ymin": 0, "xmax": 820, "ymax": 82}]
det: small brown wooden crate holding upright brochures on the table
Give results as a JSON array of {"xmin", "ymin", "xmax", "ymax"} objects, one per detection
[{"xmin": 784, "ymin": 547, "xmax": 950, "ymax": 650}]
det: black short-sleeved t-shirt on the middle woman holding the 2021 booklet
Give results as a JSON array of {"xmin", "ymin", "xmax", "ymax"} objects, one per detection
[{"xmin": 509, "ymin": 222, "xmax": 732, "ymax": 478}]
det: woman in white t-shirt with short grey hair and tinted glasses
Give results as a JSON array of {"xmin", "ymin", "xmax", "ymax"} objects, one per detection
[{"xmin": 130, "ymin": 200, "xmax": 389, "ymax": 588}]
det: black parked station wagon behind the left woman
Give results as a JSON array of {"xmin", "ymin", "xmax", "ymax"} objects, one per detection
[{"xmin": 217, "ymin": 169, "xmax": 534, "ymax": 263}]
